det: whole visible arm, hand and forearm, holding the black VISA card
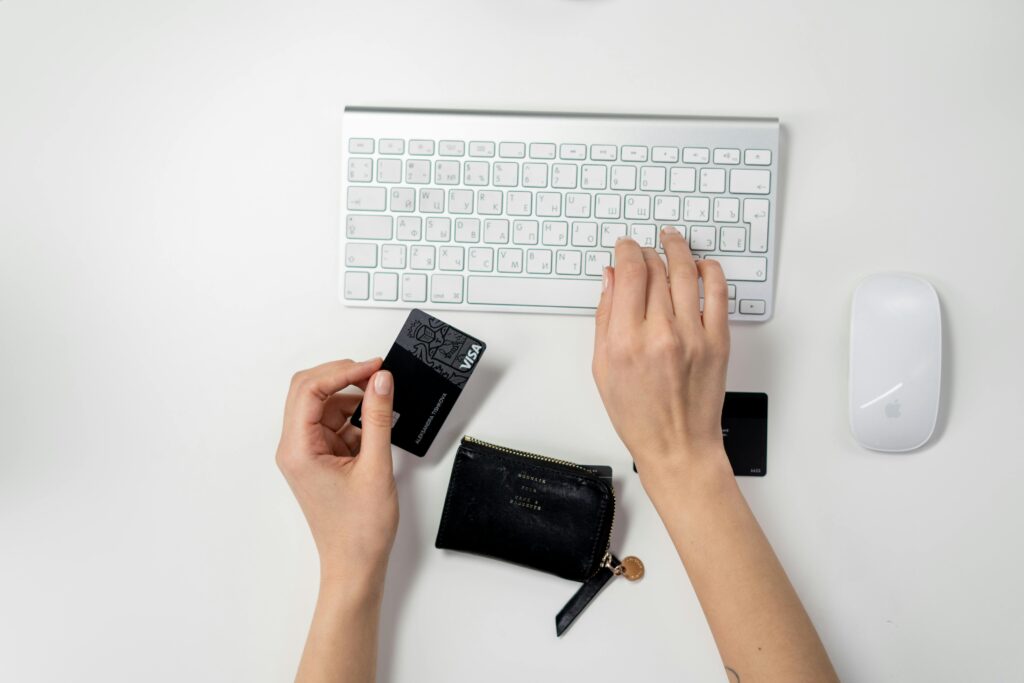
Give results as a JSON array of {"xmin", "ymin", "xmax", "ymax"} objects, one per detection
[{"xmin": 278, "ymin": 358, "xmax": 398, "ymax": 683}]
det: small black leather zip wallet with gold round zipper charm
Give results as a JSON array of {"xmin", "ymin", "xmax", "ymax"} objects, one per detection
[{"xmin": 435, "ymin": 436, "xmax": 643, "ymax": 636}]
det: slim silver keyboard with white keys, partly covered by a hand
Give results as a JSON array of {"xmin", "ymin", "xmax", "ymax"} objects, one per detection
[{"xmin": 339, "ymin": 108, "xmax": 779, "ymax": 321}]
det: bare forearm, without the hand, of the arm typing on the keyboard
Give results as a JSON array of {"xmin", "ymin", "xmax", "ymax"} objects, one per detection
[{"xmin": 644, "ymin": 452, "xmax": 837, "ymax": 682}]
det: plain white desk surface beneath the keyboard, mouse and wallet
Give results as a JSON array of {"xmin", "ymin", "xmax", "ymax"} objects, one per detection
[{"xmin": 0, "ymin": 0, "xmax": 1024, "ymax": 683}]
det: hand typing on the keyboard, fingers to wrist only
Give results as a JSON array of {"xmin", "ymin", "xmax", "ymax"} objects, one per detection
[{"xmin": 593, "ymin": 227, "xmax": 729, "ymax": 492}]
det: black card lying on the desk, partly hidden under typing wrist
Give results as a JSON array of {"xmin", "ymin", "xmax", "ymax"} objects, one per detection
[{"xmin": 633, "ymin": 391, "xmax": 768, "ymax": 477}]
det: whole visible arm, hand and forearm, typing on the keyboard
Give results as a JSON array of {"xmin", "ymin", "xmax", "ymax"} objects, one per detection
[{"xmin": 594, "ymin": 228, "xmax": 838, "ymax": 682}]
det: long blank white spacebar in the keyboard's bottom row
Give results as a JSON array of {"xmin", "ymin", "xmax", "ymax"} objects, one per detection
[{"xmin": 466, "ymin": 275, "xmax": 601, "ymax": 308}]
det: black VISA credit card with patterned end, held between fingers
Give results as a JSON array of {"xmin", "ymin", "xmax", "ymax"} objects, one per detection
[{"xmin": 351, "ymin": 308, "xmax": 486, "ymax": 458}]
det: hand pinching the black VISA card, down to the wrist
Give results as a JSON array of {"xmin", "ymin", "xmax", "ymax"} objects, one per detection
[{"xmin": 276, "ymin": 358, "xmax": 398, "ymax": 587}]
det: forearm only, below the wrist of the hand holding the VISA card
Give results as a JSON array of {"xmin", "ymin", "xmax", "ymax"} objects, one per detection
[{"xmin": 295, "ymin": 573, "xmax": 384, "ymax": 683}]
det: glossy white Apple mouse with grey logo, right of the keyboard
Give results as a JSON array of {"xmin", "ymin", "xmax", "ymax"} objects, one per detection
[{"xmin": 850, "ymin": 272, "xmax": 942, "ymax": 453}]
